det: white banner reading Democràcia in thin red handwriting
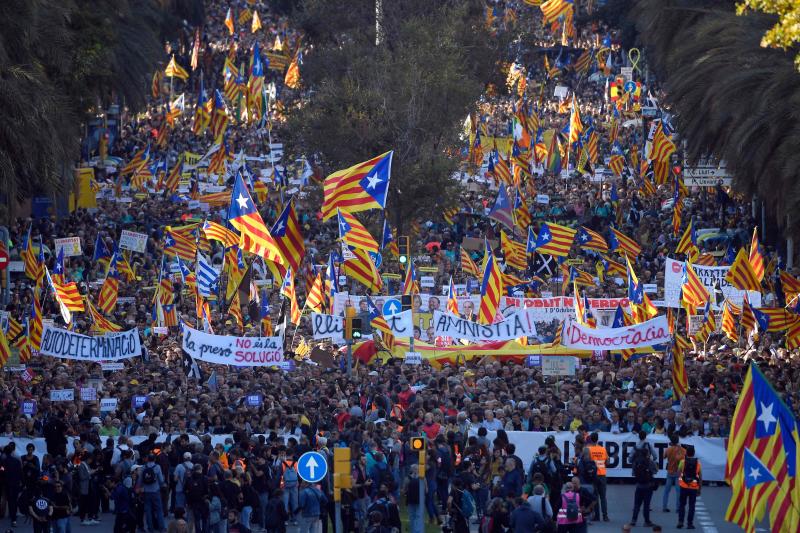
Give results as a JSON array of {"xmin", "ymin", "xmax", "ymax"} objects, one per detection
[{"xmin": 561, "ymin": 315, "xmax": 672, "ymax": 350}]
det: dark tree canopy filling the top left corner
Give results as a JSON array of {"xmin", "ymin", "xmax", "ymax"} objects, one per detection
[{"xmin": 0, "ymin": 0, "xmax": 202, "ymax": 204}]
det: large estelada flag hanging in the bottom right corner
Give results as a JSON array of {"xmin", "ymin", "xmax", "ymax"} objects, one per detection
[{"xmin": 725, "ymin": 363, "xmax": 800, "ymax": 531}]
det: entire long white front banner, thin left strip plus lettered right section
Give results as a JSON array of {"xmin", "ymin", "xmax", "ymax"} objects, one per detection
[{"xmin": 0, "ymin": 431, "xmax": 727, "ymax": 481}]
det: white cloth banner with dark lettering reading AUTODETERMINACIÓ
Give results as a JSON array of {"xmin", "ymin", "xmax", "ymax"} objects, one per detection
[{"xmin": 39, "ymin": 324, "xmax": 142, "ymax": 362}]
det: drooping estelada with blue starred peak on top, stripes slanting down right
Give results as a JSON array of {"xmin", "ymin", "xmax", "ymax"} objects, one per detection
[{"xmin": 228, "ymin": 172, "xmax": 284, "ymax": 265}]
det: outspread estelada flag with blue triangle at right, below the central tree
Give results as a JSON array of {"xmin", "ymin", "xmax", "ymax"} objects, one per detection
[{"xmin": 322, "ymin": 152, "xmax": 394, "ymax": 220}]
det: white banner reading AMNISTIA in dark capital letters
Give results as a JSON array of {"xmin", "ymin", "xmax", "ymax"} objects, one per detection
[{"xmin": 433, "ymin": 309, "xmax": 536, "ymax": 342}]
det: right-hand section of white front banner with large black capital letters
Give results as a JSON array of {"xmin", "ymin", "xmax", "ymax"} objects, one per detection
[{"xmin": 470, "ymin": 430, "xmax": 727, "ymax": 481}]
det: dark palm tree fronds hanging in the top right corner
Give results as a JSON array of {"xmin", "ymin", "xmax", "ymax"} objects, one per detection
[{"xmin": 630, "ymin": 0, "xmax": 800, "ymax": 236}]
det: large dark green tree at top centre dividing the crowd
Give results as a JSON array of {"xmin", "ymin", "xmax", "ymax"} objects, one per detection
[{"xmin": 281, "ymin": 0, "xmax": 504, "ymax": 233}]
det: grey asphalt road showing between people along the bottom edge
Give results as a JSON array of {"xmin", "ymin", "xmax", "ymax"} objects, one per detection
[{"xmin": 0, "ymin": 485, "xmax": 752, "ymax": 533}]
